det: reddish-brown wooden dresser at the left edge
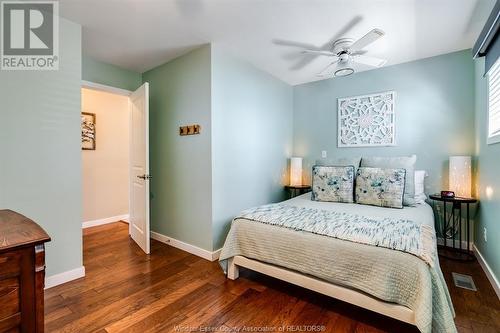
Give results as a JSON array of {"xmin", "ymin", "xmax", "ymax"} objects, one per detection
[{"xmin": 0, "ymin": 210, "xmax": 50, "ymax": 333}]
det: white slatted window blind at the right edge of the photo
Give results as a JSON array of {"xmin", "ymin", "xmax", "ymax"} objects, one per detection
[{"xmin": 488, "ymin": 59, "xmax": 500, "ymax": 139}]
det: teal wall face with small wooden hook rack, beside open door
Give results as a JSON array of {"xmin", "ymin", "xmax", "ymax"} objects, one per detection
[{"xmin": 143, "ymin": 46, "xmax": 212, "ymax": 250}]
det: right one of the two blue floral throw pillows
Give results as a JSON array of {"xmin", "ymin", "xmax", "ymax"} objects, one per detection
[{"xmin": 356, "ymin": 167, "xmax": 406, "ymax": 208}]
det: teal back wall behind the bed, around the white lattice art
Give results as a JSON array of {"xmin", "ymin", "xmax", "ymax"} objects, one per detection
[{"xmin": 294, "ymin": 50, "xmax": 475, "ymax": 193}]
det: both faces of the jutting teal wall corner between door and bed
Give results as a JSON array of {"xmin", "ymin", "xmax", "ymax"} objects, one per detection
[{"xmin": 143, "ymin": 45, "xmax": 293, "ymax": 251}]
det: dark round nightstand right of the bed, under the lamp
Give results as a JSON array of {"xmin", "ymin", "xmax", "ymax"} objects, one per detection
[{"xmin": 429, "ymin": 194, "xmax": 477, "ymax": 261}]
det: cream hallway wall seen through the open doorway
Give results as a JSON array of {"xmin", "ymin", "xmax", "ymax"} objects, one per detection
[{"xmin": 82, "ymin": 88, "xmax": 130, "ymax": 222}]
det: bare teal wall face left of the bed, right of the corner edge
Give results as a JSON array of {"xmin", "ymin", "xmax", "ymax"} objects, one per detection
[{"xmin": 212, "ymin": 44, "xmax": 293, "ymax": 250}]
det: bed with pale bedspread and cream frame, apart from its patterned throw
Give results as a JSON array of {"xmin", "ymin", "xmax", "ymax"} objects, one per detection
[{"xmin": 220, "ymin": 194, "xmax": 456, "ymax": 332}]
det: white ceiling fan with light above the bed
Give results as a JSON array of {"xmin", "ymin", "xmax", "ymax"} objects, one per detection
[{"xmin": 282, "ymin": 29, "xmax": 387, "ymax": 77}]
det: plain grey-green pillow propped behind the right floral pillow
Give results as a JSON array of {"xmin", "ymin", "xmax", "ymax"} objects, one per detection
[{"xmin": 361, "ymin": 155, "xmax": 417, "ymax": 206}]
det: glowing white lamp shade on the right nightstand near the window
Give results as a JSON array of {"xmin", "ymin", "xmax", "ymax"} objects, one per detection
[{"xmin": 450, "ymin": 156, "xmax": 472, "ymax": 198}]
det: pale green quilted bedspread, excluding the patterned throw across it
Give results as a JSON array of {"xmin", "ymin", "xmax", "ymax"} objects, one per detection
[{"xmin": 220, "ymin": 195, "xmax": 456, "ymax": 333}]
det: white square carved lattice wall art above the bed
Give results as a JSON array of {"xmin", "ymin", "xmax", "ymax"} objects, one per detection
[{"xmin": 338, "ymin": 91, "xmax": 396, "ymax": 147}]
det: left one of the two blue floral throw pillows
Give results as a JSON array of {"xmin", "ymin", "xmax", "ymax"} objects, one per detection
[{"xmin": 312, "ymin": 165, "xmax": 354, "ymax": 203}]
